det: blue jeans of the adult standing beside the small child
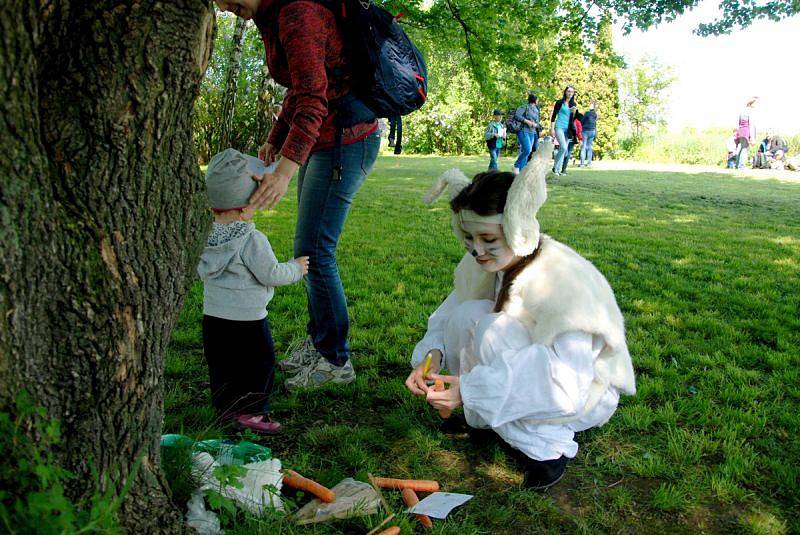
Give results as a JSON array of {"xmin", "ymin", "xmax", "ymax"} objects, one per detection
[{"xmin": 294, "ymin": 132, "xmax": 380, "ymax": 366}]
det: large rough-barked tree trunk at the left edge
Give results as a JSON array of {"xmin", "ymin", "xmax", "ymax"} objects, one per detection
[{"xmin": 0, "ymin": 0, "xmax": 214, "ymax": 533}]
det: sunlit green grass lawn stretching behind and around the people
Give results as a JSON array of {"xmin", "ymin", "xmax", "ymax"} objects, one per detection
[{"xmin": 164, "ymin": 155, "xmax": 800, "ymax": 534}]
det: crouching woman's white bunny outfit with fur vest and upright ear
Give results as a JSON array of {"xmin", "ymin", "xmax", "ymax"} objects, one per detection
[{"xmin": 411, "ymin": 141, "xmax": 636, "ymax": 460}]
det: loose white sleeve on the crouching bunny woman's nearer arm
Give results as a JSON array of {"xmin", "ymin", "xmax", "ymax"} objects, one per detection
[{"xmin": 460, "ymin": 331, "xmax": 600, "ymax": 427}]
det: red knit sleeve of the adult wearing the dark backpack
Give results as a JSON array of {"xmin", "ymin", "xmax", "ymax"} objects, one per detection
[{"xmin": 270, "ymin": 2, "xmax": 336, "ymax": 164}]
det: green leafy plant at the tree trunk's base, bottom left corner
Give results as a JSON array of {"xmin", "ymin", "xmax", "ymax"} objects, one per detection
[{"xmin": 0, "ymin": 391, "xmax": 126, "ymax": 534}]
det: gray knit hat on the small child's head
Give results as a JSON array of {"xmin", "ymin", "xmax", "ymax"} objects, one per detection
[{"xmin": 206, "ymin": 149, "xmax": 263, "ymax": 210}]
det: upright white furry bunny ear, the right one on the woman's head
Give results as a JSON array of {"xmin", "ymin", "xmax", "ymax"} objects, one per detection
[{"xmin": 503, "ymin": 139, "xmax": 553, "ymax": 256}]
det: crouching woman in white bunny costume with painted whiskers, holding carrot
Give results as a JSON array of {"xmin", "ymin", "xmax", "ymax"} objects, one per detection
[{"xmin": 406, "ymin": 141, "xmax": 636, "ymax": 489}]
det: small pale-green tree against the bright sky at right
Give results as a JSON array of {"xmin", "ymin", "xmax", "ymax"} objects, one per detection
[{"xmin": 622, "ymin": 56, "xmax": 675, "ymax": 140}]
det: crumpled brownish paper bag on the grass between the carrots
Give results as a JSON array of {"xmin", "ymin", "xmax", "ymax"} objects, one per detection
[{"xmin": 294, "ymin": 477, "xmax": 381, "ymax": 525}]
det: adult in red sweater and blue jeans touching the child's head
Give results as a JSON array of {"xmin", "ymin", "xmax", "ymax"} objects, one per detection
[{"xmin": 216, "ymin": 0, "xmax": 380, "ymax": 390}]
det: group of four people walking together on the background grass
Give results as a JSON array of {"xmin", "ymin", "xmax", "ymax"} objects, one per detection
[{"xmin": 484, "ymin": 85, "xmax": 597, "ymax": 175}]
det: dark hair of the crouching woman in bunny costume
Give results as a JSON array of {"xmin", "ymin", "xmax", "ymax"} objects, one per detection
[{"xmin": 450, "ymin": 171, "xmax": 541, "ymax": 312}]
